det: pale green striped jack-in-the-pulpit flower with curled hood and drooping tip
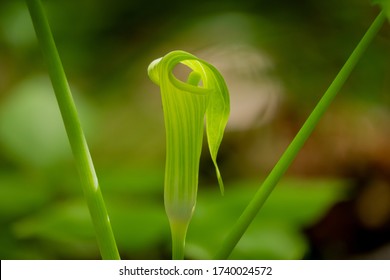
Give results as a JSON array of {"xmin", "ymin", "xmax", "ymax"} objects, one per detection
[{"xmin": 148, "ymin": 51, "xmax": 230, "ymax": 259}]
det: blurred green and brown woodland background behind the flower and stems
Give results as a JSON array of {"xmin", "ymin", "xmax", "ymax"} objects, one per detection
[{"xmin": 0, "ymin": 0, "xmax": 390, "ymax": 259}]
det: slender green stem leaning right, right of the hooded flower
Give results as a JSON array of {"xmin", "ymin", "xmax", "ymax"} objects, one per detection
[{"xmin": 215, "ymin": 12, "xmax": 386, "ymax": 259}]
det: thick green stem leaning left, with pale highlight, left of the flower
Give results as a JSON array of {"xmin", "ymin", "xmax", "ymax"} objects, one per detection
[{"xmin": 26, "ymin": 0, "xmax": 120, "ymax": 260}]
